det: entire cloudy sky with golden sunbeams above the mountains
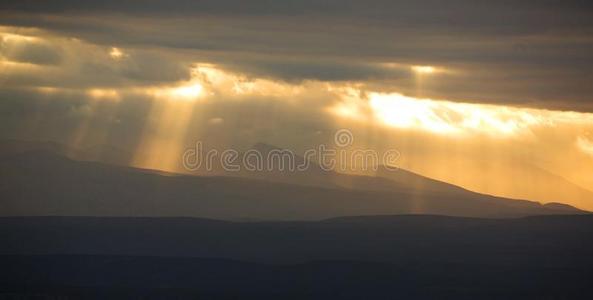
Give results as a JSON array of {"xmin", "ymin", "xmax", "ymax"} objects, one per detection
[{"xmin": 0, "ymin": 0, "xmax": 593, "ymax": 209}]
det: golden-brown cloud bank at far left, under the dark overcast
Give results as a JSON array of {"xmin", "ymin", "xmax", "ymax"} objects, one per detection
[{"xmin": 0, "ymin": 28, "xmax": 191, "ymax": 89}]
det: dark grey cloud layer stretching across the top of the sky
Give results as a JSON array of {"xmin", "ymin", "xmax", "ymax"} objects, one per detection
[{"xmin": 0, "ymin": 0, "xmax": 593, "ymax": 111}]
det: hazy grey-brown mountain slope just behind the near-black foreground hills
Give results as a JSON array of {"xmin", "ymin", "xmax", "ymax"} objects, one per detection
[{"xmin": 0, "ymin": 151, "xmax": 581, "ymax": 220}]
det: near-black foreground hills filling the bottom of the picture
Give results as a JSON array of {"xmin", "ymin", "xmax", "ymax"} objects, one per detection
[{"xmin": 0, "ymin": 215, "xmax": 593, "ymax": 299}]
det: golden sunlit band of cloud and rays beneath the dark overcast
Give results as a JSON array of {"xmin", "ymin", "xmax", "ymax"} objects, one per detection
[{"xmin": 0, "ymin": 27, "xmax": 593, "ymax": 210}]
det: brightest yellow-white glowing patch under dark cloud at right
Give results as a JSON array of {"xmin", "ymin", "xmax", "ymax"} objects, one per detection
[{"xmin": 328, "ymin": 90, "xmax": 593, "ymax": 139}]
